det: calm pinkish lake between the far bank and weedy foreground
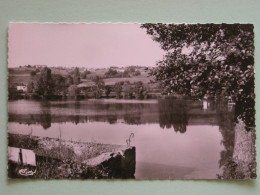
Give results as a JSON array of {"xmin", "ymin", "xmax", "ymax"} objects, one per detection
[{"xmin": 8, "ymin": 99, "xmax": 234, "ymax": 179}]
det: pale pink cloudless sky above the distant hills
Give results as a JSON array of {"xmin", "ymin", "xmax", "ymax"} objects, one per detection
[{"xmin": 8, "ymin": 23, "xmax": 164, "ymax": 68}]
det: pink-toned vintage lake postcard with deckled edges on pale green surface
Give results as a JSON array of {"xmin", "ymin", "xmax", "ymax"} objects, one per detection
[{"xmin": 7, "ymin": 23, "xmax": 257, "ymax": 180}]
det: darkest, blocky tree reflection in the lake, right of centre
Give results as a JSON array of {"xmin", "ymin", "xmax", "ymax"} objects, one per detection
[{"xmin": 158, "ymin": 99, "xmax": 188, "ymax": 133}]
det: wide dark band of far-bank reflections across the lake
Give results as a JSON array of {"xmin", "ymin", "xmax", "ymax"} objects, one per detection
[{"xmin": 8, "ymin": 99, "xmax": 218, "ymax": 133}]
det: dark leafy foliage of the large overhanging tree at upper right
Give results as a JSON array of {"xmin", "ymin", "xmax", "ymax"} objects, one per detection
[{"xmin": 141, "ymin": 24, "xmax": 255, "ymax": 129}]
